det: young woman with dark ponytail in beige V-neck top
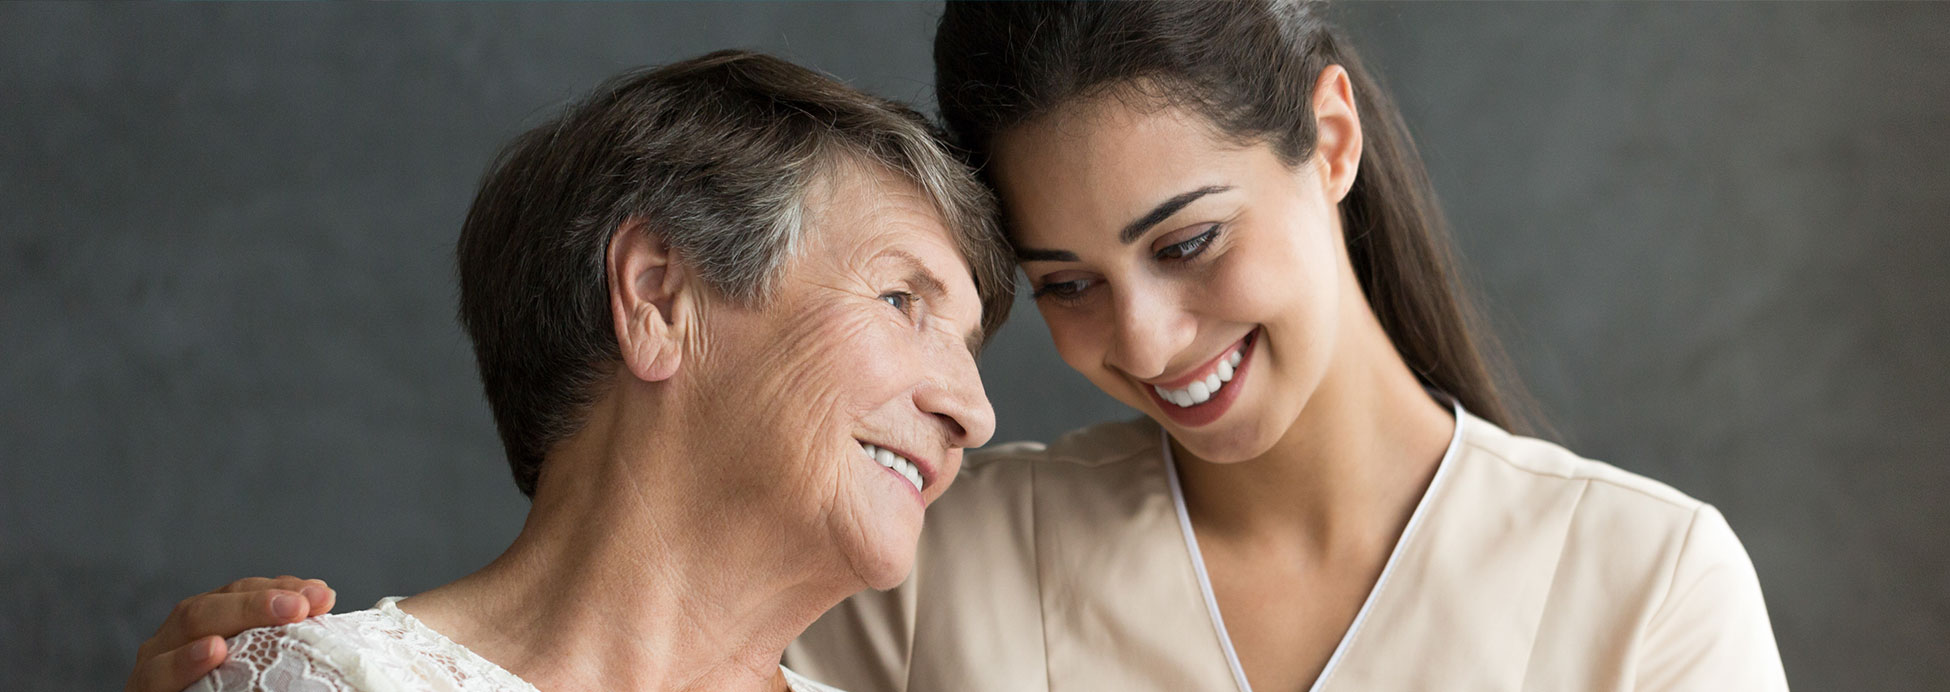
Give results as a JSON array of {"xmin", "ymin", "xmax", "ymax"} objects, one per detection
[{"xmin": 129, "ymin": 0, "xmax": 1786, "ymax": 692}]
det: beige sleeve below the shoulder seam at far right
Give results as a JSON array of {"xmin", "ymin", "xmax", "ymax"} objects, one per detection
[{"xmin": 1638, "ymin": 505, "xmax": 1788, "ymax": 690}]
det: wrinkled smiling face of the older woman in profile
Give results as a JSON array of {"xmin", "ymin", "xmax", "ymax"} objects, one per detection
[{"xmin": 694, "ymin": 166, "xmax": 995, "ymax": 589}]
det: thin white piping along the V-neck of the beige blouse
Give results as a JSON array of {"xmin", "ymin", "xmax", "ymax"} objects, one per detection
[{"xmin": 1158, "ymin": 392, "xmax": 1464, "ymax": 692}]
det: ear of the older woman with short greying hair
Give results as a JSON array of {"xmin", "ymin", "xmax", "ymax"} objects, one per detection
[{"xmin": 606, "ymin": 218, "xmax": 696, "ymax": 382}]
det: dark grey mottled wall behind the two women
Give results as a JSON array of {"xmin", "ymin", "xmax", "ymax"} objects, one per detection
[{"xmin": 0, "ymin": 4, "xmax": 1950, "ymax": 690}]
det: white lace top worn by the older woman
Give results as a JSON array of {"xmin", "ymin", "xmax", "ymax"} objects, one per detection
[{"xmin": 189, "ymin": 598, "xmax": 839, "ymax": 692}]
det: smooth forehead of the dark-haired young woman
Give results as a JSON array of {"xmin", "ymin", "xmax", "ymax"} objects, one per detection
[{"xmin": 993, "ymin": 96, "xmax": 1271, "ymax": 244}]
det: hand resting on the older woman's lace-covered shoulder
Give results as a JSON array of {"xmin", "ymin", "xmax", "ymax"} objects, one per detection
[{"xmin": 125, "ymin": 575, "xmax": 337, "ymax": 692}]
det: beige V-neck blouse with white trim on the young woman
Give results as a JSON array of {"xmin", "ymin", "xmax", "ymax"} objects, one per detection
[{"xmin": 786, "ymin": 407, "xmax": 1786, "ymax": 692}]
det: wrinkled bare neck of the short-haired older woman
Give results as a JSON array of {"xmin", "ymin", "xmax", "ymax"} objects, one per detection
[{"xmin": 400, "ymin": 389, "xmax": 862, "ymax": 692}]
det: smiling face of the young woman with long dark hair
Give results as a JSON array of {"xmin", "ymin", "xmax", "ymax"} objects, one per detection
[{"xmin": 995, "ymin": 81, "xmax": 1365, "ymax": 462}]
